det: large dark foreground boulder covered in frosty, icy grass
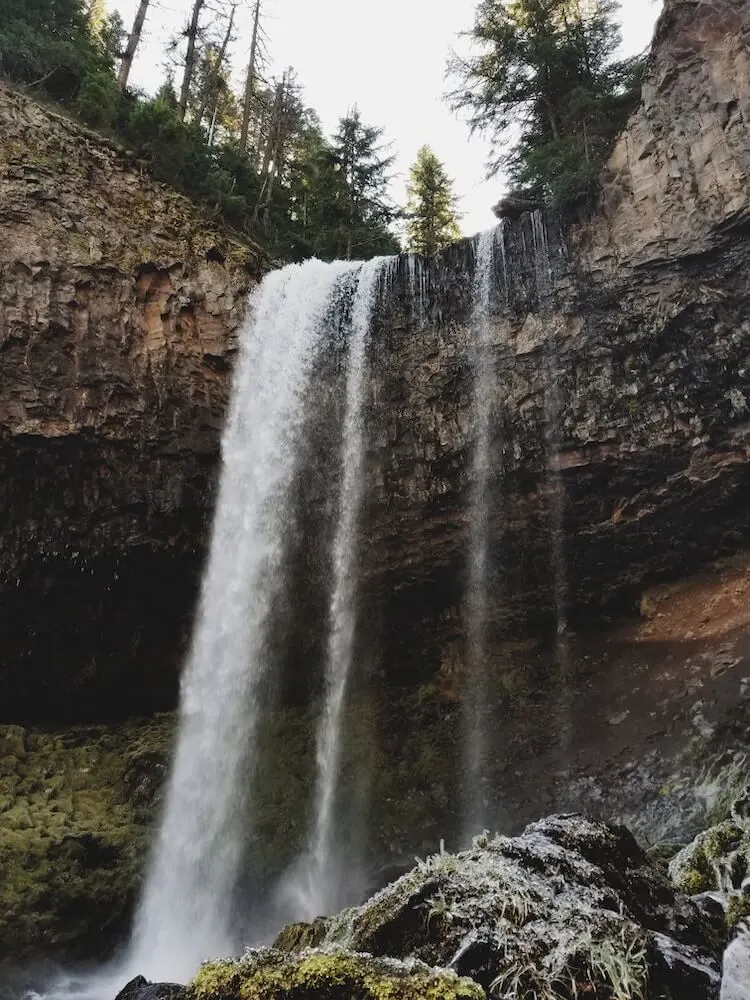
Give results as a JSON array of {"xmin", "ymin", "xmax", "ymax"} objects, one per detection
[{"xmin": 326, "ymin": 815, "xmax": 720, "ymax": 1000}]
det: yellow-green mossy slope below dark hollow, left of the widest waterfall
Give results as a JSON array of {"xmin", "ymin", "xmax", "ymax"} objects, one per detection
[{"xmin": 0, "ymin": 716, "xmax": 173, "ymax": 963}]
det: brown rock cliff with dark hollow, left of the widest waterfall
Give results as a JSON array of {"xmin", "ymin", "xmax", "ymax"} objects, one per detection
[{"xmin": 0, "ymin": 89, "xmax": 258, "ymax": 722}]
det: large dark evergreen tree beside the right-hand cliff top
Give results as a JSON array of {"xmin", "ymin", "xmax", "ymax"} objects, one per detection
[{"xmin": 450, "ymin": 0, "xmax": 642, "ymax": 204}]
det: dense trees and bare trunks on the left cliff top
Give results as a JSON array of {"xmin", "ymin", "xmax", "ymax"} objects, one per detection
[{"xmin": 0, "ymin": 0, "xmax": 406, "ymax": 260}]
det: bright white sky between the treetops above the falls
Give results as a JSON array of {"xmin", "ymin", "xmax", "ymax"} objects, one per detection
[{"xmin": 109, "ymin": 0, "xmax": 661, "ymax": 235}]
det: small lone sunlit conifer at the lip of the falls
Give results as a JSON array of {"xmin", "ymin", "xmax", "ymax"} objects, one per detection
[{"xmin": 406, "ymin": 146, "xmax": 461, "ymax": 256}]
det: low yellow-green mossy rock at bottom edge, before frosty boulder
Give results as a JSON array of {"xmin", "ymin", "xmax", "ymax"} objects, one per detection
[{"xmin": 187, "ymin": 948, "xmax": 485, "ymax": 1000}]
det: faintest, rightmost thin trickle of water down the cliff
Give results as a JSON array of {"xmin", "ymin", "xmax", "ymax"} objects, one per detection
[{"xmin": 531, "ymin": 211, "xmax": 573, "ymax": 761}]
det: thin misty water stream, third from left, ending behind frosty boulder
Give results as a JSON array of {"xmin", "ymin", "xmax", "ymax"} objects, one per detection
[{"xmin": 463, "ymin": 229, "xmax": 502, "ymax": 840}]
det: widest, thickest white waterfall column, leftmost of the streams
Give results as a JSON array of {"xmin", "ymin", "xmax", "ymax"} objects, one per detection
[{"xmin": 129, "ymin": 260, "xmax": 354, "ymax": 981}]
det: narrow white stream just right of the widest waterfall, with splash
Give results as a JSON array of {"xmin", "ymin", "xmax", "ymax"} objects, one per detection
[{"xmin": 279, "ymin": 257, "xmax": 398, "ymax": 920}]
